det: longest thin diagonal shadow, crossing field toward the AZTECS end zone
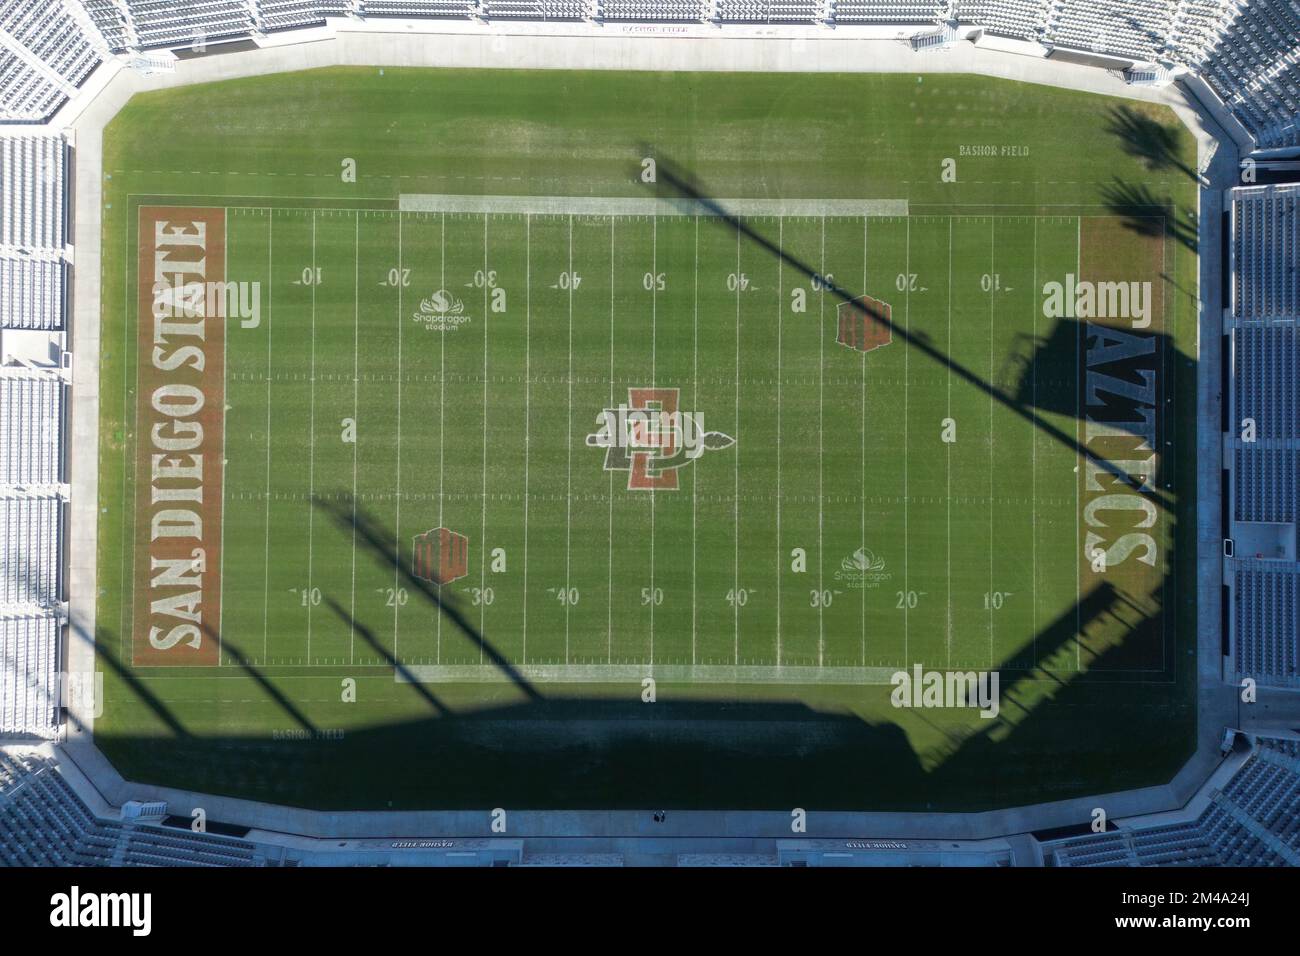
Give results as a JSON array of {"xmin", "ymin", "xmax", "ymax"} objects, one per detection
[{"xmin": 642, "ymin": 147, "xmax": 1173, "ymax": 511}]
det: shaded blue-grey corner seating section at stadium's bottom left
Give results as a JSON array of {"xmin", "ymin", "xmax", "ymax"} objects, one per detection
[{"xmin": 0, "ymin": 749, "xmax": 263, "ymax": 866}]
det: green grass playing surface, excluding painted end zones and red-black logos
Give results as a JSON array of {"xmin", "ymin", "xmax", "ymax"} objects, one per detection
[{"xmin": 96, "ymin": 69, "xmax": 1196, "ymax": 809}]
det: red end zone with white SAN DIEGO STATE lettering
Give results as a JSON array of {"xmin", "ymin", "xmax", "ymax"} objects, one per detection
[{"xmin": 131, "ymin": 206, "xmax": 226, "ymax": 667}]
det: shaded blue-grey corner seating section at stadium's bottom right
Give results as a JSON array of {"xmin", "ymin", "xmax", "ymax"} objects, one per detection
[{"xmin": 1043, "ymin": 737, "xmax": 1300, "ymax": 866}]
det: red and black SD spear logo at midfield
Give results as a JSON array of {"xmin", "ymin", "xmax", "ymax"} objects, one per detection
[{"xmin": 586, "ymin": 389, "xmax": 736, "ymax": 492}]
